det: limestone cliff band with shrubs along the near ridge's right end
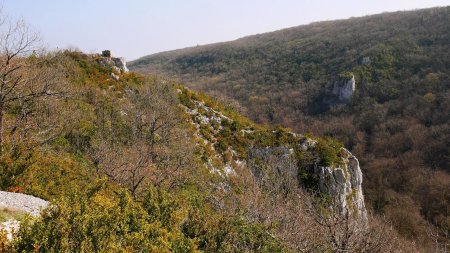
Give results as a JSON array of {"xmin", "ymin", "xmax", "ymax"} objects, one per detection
[{"xmin": 178, "ymin": 89, "xmax": 367, "ymax": 219}]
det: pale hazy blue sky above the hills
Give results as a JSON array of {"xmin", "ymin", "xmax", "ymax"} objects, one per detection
[{"xmin": 0, "ymin": 0, "xmax": 450, "ymax": 60}]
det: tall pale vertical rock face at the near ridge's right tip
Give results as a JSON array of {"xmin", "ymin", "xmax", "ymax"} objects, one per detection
[{"xmin": 314, "ymin": 148, "xmax": 367, "ymax": 219}]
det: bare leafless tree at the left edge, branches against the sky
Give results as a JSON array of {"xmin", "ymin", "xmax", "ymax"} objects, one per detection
[{"xmin": 0, "ymin": 14, "xmax": 55, "ymax": 154}]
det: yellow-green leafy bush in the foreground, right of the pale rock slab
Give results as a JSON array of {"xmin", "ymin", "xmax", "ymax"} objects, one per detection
[{"xmin": 13, "ymin": 186, "xmax": 196, "ymax": 252}]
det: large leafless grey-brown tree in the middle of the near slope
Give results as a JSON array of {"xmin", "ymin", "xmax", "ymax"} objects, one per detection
[{"xmin": 90, "ymin": 78, "xmax": 194, "ymax": 197}]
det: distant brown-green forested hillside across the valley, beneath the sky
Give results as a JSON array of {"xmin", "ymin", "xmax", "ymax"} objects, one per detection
[{"xmin": 129, "ymin": 7, "xmax": 450, "ymax": 247}]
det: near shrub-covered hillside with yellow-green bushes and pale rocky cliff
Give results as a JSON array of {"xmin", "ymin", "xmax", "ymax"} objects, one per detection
[{"xmin": 0, "ymin": 47, "xmax": 426, "ymax": 252}]
